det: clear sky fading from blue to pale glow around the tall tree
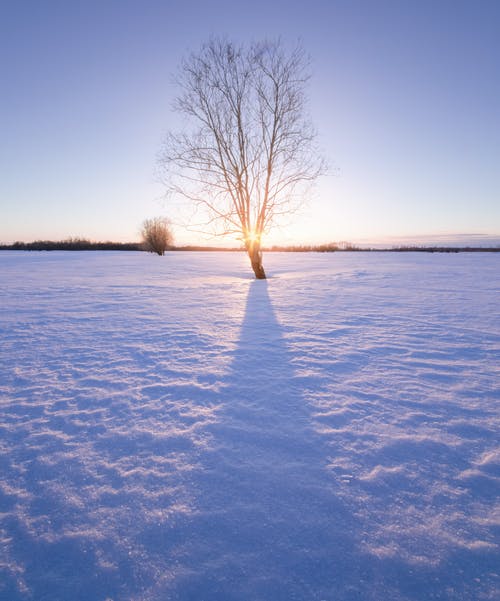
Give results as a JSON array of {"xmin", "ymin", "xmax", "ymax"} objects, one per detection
[{"xmin": 0, "ymin": 0, "xmax": 500, "ymax": 242}]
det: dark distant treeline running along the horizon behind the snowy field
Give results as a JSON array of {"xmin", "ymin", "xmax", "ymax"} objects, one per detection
[{"xmin": 0, "ymin": 238, "xmax": 500, "ymax": 253}]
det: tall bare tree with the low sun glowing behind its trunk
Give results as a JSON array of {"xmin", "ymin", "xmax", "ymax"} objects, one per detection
[{"xmin": 160, "ymin": 39, "xmax": 324, "ymax": 279}]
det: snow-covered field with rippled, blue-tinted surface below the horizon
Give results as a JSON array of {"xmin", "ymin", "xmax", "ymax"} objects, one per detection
[{"xmin": 0, "ymin": 252, "xmax": 500, "ymax": 601}]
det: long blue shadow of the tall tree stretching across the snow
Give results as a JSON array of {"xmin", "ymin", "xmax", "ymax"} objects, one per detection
[{"xmin": 164, "ymin": 281, "xmax": 366, "ymax": 600}]
